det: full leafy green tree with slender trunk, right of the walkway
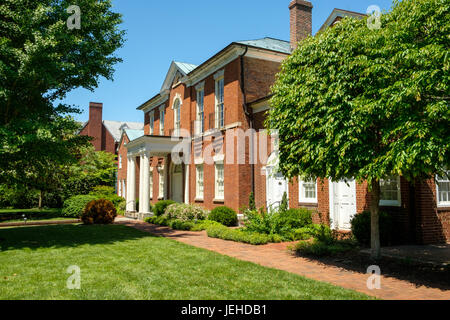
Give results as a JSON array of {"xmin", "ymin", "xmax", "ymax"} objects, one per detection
[{"xmin": 267, "ymin": 0, "xmax": 450, "ymax": 258}]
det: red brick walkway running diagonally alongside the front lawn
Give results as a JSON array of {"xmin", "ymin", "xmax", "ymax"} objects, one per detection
[{"xmin": 116, "ymin": 218, "xmax": 450, "ymax": 300}]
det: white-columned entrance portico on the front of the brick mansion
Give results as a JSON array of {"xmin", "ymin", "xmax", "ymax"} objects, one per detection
[{"xmin": 126, "ymin": 135, "xmax": 189, "ymax": 219}]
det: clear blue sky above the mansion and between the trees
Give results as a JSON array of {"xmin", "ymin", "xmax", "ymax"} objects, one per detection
[{"xmin": 64, "ymin": 0, "xmax": 392, "ymax": 122}]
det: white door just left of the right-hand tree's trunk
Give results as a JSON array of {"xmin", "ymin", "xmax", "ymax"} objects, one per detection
[{"xmin": 333, "ymin": 180, "xmax": 356, "ymax": 230}]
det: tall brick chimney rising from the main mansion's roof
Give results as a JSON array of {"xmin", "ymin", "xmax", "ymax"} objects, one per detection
[{"xmin": 289, "ymin": 0, "xmax": 313, "ymax": 49}]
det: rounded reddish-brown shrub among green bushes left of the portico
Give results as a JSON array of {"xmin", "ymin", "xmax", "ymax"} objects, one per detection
[{"xmin": 81, "ymin": 199, "xmax": 117, "ymax": 224}]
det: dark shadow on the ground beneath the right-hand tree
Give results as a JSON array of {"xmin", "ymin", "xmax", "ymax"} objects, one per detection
[{"xmin": 294, "ymin": 251, "xmax": 450, "ymax": 290}]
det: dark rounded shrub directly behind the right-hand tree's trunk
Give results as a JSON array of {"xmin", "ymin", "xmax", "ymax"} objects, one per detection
[{"xmin": 351, "ymin": 211, "xmax": 394, "ymax": 246}]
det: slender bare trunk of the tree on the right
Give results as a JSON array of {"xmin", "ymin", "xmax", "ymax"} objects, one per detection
[{"xmin": 370, "ymin": 180, "xmax": 381, "ymax": 260}]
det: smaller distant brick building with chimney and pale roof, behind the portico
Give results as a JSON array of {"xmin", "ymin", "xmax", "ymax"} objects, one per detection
[{"xmin": 79, "ymin": 102, "xmax": 144, "ymax": 154}]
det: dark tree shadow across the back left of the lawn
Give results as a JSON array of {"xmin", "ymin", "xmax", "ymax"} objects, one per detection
[{"xmin": 0, "ymin": 224, "xmax": 154, "ymax": 251}]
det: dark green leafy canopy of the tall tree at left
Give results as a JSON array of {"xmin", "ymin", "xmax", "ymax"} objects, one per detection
[{"xmin": 0, "ymin": 0, "xmax": 124, "ymax": 185}]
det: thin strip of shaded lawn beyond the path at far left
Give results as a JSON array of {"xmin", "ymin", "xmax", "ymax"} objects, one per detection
[{"xmin": 0, "ymin": 209, "xmax": 73, "ymax": 223}]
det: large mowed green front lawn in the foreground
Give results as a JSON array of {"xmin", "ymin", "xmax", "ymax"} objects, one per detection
[{"xmin": 0, "ymin": 225, "xmax": 369, "ymax": 300}]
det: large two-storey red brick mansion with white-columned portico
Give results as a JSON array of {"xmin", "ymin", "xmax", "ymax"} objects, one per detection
[{"xmin": 119, "ymin": 0, "xmax": 450, "ymax": 243}]
